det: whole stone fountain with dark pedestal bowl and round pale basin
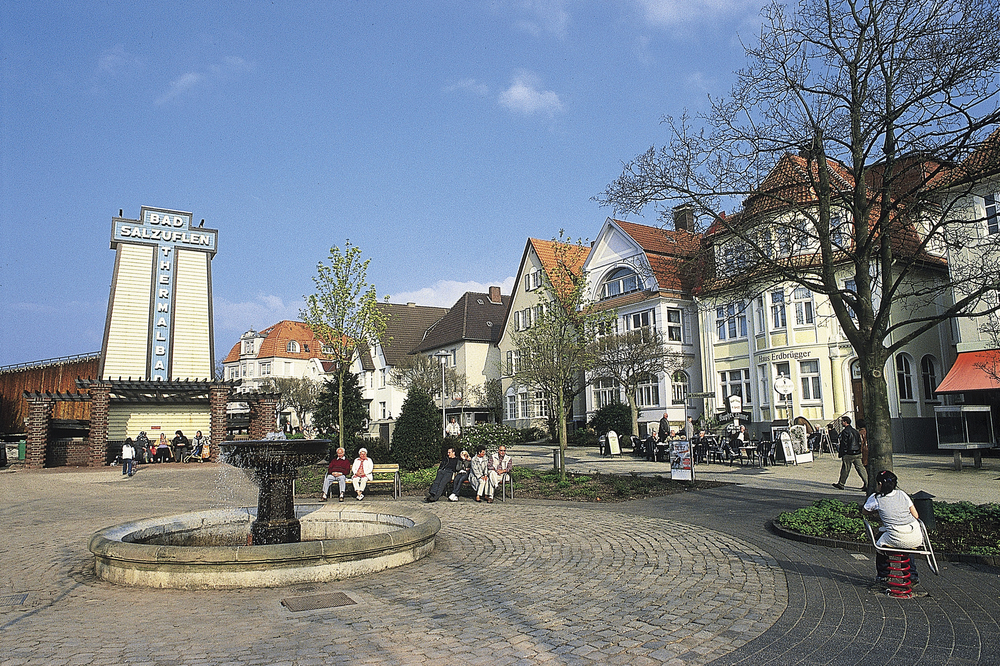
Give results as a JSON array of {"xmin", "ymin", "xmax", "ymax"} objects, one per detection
[{"xmin": 89, "ymin": 439, "xmax": 441, "ymax": 589}]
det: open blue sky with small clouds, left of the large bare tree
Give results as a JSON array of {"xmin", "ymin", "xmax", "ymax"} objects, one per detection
[{"xmin": 0, "ymin": 0, "xmax": 762, "ymax": 365}]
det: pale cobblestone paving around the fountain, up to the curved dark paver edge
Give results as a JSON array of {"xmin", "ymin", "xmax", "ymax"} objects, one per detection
[{"xmin": 0, "ymin": 466, "xmax": 786, "ymax": 666}]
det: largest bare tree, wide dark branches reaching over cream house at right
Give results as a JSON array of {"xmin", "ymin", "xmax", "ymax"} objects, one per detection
[{"xmin": 598, "ymin": 0, "xmax": 1000, "ymax": 478}]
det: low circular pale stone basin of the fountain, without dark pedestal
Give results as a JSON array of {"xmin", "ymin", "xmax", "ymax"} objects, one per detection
[{"xmin": 89, "ymin": 506, "xmax": 441, "ymax": 589}]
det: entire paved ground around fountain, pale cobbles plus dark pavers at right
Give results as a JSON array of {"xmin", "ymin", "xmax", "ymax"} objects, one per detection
[{"xmin": 0, "ymin": 451, "xmax": 1000, "ymax": 666}]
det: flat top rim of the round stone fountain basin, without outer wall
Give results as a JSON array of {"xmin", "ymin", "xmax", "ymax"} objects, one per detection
[{"xmin": 88, "ymin": 507, "xmax": 441, "ymax": 567}]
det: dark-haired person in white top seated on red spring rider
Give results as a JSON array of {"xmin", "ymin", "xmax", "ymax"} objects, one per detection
[{"xmin": 861, "ymin": 470, "xmax": 924, "ymax": 582}]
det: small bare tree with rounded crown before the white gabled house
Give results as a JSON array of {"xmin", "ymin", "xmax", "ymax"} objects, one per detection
[{"xmin": 593, "ymin": 327, "xmax": 688, "ymax": 433}]
